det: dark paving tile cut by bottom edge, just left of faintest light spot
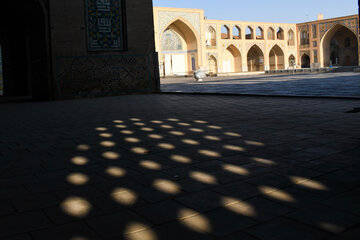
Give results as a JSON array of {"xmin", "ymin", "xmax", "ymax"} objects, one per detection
[{"xmin": 246, "ymin": 218, "xmax": 331, "ymax": 240}]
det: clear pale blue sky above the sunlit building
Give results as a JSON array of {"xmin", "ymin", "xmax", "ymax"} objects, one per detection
[{"xmin": 153, "ymin": 0, "xmax": 358, "ymax": 23}]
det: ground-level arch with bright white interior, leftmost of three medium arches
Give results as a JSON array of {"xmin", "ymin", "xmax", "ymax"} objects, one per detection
[{"xmin": 223, "ymin": 44, "xmax": 242, "ymax": 73}]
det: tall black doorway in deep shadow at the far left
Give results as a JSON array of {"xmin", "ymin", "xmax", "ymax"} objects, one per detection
[{"xmin": 0, "ymin": 0, "xmax": 53, "ymax": 100}]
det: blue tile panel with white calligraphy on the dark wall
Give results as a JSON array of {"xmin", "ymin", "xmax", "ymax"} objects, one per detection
[{"xmin": 85, "ymin": 0, "xmax": 125, "ymax": 51}]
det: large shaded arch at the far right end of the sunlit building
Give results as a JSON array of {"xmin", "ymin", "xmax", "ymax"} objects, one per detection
[{"xmin": 321, "ymin": 24, "xmax": 358, "ymax": 67}]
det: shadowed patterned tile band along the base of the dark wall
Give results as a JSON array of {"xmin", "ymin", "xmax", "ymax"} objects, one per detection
[{"xmin": 56, "ymin": 55, "xmax": 152, "ymax": 98}]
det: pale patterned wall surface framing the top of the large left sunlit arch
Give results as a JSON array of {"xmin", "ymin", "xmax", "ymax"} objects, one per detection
[{"xmin": 157, "ymin": 10, "xmax": 202, "ymax": 38}]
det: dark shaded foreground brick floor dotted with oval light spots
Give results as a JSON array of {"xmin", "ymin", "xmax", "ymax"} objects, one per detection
[{"xmin": 0, "ymin": 94, "xmax": 360, "ymax": 240}]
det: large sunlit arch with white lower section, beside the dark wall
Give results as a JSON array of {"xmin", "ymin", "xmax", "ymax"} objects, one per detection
[{"xmin": 161, "ymin": 19, "xmax": 199, "ymax": 75}]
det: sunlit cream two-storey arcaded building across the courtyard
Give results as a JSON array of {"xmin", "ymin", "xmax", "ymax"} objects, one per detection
[{"xmin": 154, "ymin": 7, "xmax": 359, "ymax": 76}]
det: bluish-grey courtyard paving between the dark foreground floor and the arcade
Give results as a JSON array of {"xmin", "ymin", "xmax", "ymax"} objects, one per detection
[{"xmin": 161, "ymin": 72, "xmax": 360, "ymax": 97}]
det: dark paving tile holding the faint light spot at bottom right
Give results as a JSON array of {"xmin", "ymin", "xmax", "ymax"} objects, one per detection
[{"xmin": 287, "ymin": 204, "xmax": 360, "ymax": 233}]
